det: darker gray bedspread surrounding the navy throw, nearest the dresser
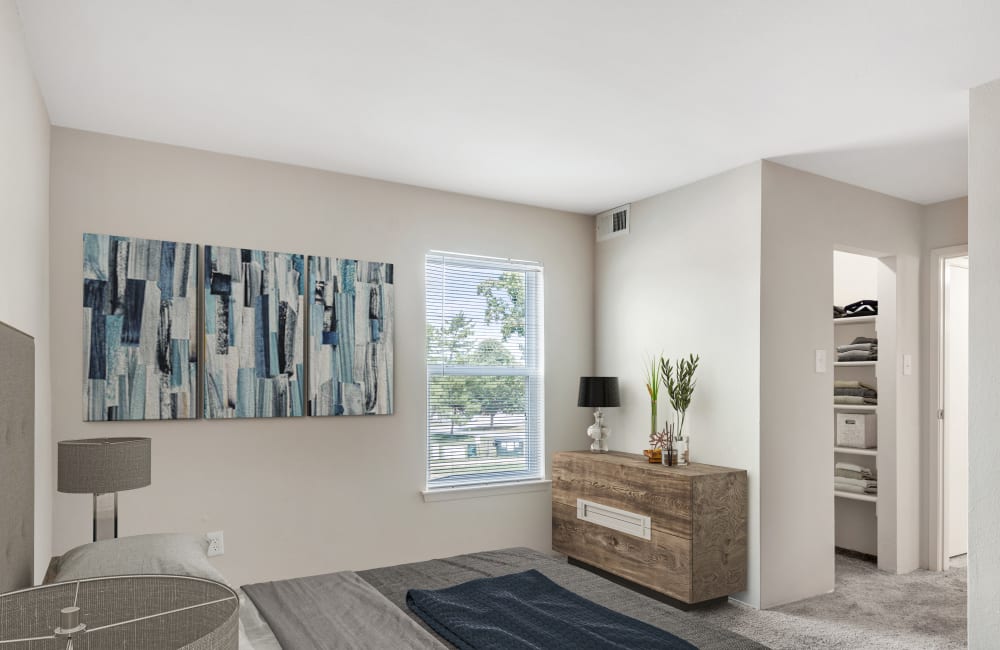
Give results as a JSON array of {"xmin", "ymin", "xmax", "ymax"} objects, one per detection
[{"xmin": 357, "ymin": 548, "xmax": 767, "ymax": 650}]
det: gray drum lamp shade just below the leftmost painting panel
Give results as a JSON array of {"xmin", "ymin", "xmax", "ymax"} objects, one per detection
[{"xmin": 58, "ymin": 438, "xmax": 150, "ymax": 494}]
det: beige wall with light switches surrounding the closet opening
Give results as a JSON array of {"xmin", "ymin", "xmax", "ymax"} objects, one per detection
[{"xmin": 760, "ymin": 162, "xmax": 921, "ymax": 607}]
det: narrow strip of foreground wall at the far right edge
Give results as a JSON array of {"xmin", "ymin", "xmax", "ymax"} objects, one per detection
[{"xmin": 969, "ymin": 80, "xmax": 1000, "ymax": 650}]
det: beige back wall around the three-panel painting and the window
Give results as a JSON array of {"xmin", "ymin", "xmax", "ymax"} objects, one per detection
[{"xmin": 51, "ymin": 128, "xmax": 594, "ymax": 584}]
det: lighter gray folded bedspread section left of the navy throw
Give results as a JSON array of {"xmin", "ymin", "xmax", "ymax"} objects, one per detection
[{"xmin": 243, "ymin": 571, "xmax": 445, "ymax": 650}]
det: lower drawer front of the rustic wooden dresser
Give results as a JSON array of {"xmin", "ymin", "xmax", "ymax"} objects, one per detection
[{"xmin": 552, "ymin": 503, "xmax": 691, "ymax": 602}]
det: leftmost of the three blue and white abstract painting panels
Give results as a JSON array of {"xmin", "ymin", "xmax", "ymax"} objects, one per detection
[{"xmin": 83, "ymin": 233, "xmax": 198, "ymax": 421}]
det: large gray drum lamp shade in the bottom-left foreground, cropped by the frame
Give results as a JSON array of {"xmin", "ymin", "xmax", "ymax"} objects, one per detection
[{"xmin": 0, "ymin": 575, "xmax": 239, "ymax": 650}]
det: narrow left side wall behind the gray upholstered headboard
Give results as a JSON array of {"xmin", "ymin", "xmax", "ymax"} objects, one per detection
[{"xmin": 0, "ymin": 0, "xmax": 53, "ymax": 582}]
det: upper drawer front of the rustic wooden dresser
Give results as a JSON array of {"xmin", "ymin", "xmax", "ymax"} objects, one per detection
[{"xmin": 552, "ymin": 454, "xmax": 692, "ymax": 538}]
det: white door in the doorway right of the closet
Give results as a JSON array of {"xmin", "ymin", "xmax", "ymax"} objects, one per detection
[{"xmin": 943, "ymin": 257, "xmax": 969, "ymax": 557}]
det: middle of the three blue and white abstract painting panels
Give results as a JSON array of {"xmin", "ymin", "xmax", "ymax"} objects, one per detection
[{"xmin": 204, "ymin": 246, "xmax": 306, "ymax": 418}]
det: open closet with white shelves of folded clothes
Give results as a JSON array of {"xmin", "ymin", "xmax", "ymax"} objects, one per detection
[{"xmin": 828, "ymin": 251, "xmax": 896, "ymax": 568}]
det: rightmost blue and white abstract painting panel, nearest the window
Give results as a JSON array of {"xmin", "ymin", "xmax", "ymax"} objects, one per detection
[{"xmin": 309, "ymin": 257, "xmax": 395, "ymax": 415}]
